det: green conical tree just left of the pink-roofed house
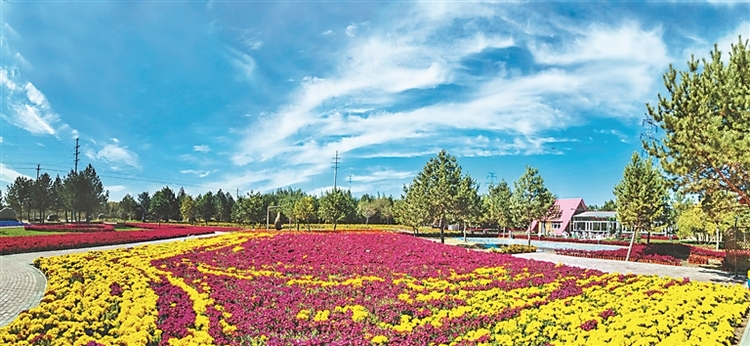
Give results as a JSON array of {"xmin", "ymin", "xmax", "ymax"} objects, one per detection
[{"xmin": 511, "ymin": 166, "xmax": 556, "ymax": 246}]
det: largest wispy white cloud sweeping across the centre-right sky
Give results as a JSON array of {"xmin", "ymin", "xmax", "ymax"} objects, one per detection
[{"xmin": 232, "ymin": 3, "xmax": 670, "ymax": 193}]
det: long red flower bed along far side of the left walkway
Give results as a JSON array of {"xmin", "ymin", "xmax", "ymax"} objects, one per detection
[{"xmin": 0, "ymin": 225, "xmax": 235, "ymax": 255}]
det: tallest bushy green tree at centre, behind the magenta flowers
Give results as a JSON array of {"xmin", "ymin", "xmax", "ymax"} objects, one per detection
[{"xmin": 404, "ymin": 150, "xmax": 470, "ymax": 243}]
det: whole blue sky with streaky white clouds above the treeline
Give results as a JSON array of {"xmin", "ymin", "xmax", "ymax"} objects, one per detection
[{"xmin": 0, "ymin": 0, "xmax": 750, "ymax": 204}]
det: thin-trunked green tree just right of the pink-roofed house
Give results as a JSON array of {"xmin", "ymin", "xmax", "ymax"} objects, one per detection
[{"xmin": 614, "ymin": 152, "xmax": 669, "ymax": 260}]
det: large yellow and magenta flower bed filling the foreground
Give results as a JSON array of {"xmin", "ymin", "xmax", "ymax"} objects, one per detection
[{"xmin": 0, "ymin": 233, "xmax": 750, "ymax": 345}]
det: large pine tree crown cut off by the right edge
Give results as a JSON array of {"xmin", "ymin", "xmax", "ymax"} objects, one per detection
[{"xmin": 643, "ymin": 37, "xmax": 750, "ymax": 204}]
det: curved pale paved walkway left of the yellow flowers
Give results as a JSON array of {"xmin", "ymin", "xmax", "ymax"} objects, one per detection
[{"xmin": 0, "ymin": 232, "xmax": 223, "ymax": 327}]
